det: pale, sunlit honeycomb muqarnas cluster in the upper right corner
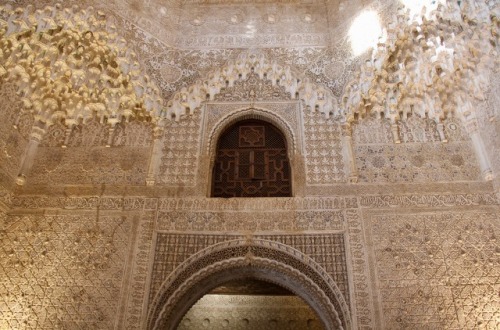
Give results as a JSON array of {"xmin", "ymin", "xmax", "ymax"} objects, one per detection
[{"xmin": 341, "ymin": 1, "xmax": 500, "ymax": 127}]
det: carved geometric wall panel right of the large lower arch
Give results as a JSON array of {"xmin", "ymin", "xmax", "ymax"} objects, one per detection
[{"xmin": 369, "ymin": 212, "xmax": 500, "ymax": 329}]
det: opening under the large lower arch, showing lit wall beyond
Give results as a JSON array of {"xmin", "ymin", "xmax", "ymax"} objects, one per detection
[{"xmin": 178, "ymin": 277, "xmax": 323, "ymax": 330}]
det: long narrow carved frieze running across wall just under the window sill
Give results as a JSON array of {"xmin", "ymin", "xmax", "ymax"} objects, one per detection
[{"xmin": 8, "ymin": 193, "xmax": 500, "ymax": 213}]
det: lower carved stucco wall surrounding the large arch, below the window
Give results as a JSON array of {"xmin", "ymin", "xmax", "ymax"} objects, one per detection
[{"xmin": 1, "ymin": 192, "xmax": 500, "ymax": 329}]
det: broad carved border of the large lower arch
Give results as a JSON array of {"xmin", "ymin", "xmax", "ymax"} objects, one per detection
[{"xmin": 147, "ymin": 239, "xmax": 352, "ymax": 329}]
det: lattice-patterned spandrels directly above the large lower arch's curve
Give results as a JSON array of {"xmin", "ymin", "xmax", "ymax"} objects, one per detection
[{"xmin": 149, "ymin": 233, "xmax": 349, "ymax": 304}]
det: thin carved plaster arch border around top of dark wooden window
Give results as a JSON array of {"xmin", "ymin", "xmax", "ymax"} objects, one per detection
[{"xmin": 206, "ymin": 106, "xmax": 298, "ymax": 161}]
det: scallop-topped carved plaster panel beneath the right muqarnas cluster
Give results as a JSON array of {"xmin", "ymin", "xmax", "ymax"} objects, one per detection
[{"xmin": 353, "ymin": 117, "xmax": 481, "ymax": 183}]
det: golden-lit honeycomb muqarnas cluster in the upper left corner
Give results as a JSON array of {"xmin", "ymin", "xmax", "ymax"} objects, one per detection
[{"xmin": 0, "ymin": 5, "xmax": 162, "ymax": 133}]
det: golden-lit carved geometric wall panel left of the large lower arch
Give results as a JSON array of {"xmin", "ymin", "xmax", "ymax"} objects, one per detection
[{"xmin": 0, "ymin": 215, "xmax": 131, "ymax": 329}]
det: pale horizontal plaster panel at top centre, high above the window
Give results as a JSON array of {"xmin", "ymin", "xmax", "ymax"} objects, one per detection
[{"xmin": 175, "ymin": 2, "xmax": 328, "ymax": 48}]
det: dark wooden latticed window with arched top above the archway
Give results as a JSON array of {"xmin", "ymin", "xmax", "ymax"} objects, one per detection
[{"xmin": 212, "ymin": 119, "xmax": 292, "ymax": 197}]
